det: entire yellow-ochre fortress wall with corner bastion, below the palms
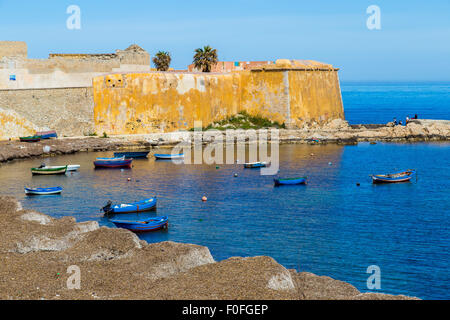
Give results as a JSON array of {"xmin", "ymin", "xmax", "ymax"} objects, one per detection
[{"xmin": 93, "ymin": 60, "xmax": 344, "ymax": 134}]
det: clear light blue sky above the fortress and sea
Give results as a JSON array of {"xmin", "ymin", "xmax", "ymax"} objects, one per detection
[{"xmin": 0, "ymin": 0, "xmax": 450, "ymax": 81}]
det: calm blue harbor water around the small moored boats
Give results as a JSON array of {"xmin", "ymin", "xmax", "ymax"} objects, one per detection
[{"xmin": 0, "ymin": 143, "xmax": 450, "ymax": 299}]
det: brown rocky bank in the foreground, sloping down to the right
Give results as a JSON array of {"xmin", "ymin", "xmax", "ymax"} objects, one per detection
[{"xmin": 0, "ymin": 197, "xmax": 413, "ymax": 300}]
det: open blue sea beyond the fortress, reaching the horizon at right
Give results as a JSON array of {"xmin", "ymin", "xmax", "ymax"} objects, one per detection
[{"xmin": 341, "ymin": 82, "xmax": 450, "ymax": 124}]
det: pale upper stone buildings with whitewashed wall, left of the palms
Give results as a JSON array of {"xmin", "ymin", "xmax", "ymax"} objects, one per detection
[{"xmin": 0, "ymin": 41, "xmax": 150, "ymax": 89}]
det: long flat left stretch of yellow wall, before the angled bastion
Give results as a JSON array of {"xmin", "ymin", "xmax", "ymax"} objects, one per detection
[{"xmin": 93, "ymin": 72, "xmax": 240, "ymax": 134}]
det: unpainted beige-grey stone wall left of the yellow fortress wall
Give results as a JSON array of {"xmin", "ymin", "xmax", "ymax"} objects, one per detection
[{"xmin": 0, "ymin": 87, "xmax": 94, "ymax": 139}]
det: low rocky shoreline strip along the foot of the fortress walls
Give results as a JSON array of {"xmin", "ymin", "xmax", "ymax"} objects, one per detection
[{"xmin": 0, "ymin": 119, "xmax": 450, "ymax": 162}]
